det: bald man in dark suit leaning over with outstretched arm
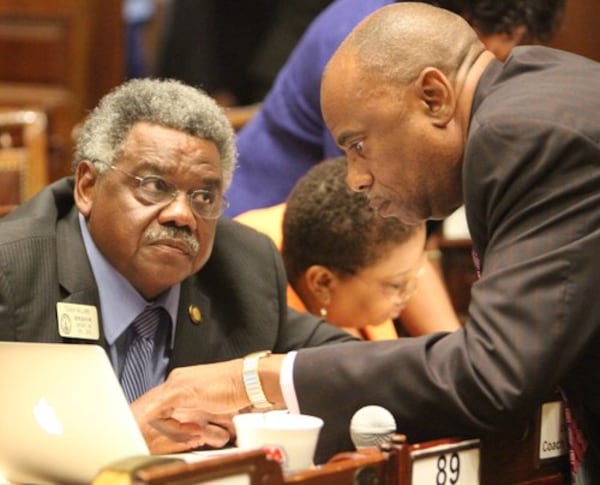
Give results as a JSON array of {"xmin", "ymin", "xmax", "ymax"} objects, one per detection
[{"xmin": 145, "ymin": 2, "xmax": 600, "ymax": 483}]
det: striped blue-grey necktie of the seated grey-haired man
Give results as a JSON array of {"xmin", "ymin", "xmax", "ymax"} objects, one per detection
[{"xmin": 121, "ymin": 306, "xmax": 169, "ymax": 402}]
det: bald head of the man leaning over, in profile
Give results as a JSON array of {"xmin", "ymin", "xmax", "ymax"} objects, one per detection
[{"xmin": 321, "ymin": 2, "xmax": 494, "ymax": 225}]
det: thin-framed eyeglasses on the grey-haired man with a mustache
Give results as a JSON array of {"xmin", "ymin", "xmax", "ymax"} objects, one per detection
[{"xmin": 94, "ymin": 160, "xmax": 229, "ymax": 219}]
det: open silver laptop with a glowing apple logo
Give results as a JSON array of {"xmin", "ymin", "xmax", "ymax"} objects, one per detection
[{"xmin": 0, "ymin": 342, "xmax": 149, "ymax": 483}]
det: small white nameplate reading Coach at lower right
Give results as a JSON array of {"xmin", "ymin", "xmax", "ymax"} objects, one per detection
[{"xmin": 538, "ymin": 400, "xmax": 569, "ymax": 461}]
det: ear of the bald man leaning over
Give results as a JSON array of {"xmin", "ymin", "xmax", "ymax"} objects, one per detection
[{"xmin": 415, "ymin": 67, "xmax": 456, "ymax": 128}]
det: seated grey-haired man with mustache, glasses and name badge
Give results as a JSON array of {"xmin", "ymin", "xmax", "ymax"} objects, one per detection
[{"xmin": 0, "ymin": 79, "xmax": 349, "ymax": 452}]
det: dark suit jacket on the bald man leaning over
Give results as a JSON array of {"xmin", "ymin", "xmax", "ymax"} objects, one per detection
[{"xmin": 294, "ymin": 47, "xmax": 600, "ymax": 466}]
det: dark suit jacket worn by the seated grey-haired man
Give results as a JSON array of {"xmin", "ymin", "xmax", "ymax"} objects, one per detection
[{"xmin": 0, "ymin": 179, "xmax": 352, "ymax": 374}]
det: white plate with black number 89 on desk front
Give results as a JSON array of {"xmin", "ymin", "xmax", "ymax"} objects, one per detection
[{"xmin": 410, "ymin": 439, "xmax": 480, "ymax": 485}]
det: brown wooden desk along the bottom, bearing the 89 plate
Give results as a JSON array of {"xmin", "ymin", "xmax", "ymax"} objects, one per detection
[{"xmin": 93, "ymin": 419, "xmax": 570, "ymax": 485}]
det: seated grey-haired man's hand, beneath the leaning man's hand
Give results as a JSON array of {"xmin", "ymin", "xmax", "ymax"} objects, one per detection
[{"xmin": 131, "ymin": 382, "xmax": 234, "ymax": 454}]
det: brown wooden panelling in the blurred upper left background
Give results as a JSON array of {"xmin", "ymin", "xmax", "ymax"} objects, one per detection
[{"xmin": 0, "ymin": 0, "xmax": 124, "ymax": 180}]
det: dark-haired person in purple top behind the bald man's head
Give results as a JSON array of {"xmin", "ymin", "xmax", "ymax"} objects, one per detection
[{"xmin": 226, "ymin": 0, "xmax": 565, "ymax": 216}]
